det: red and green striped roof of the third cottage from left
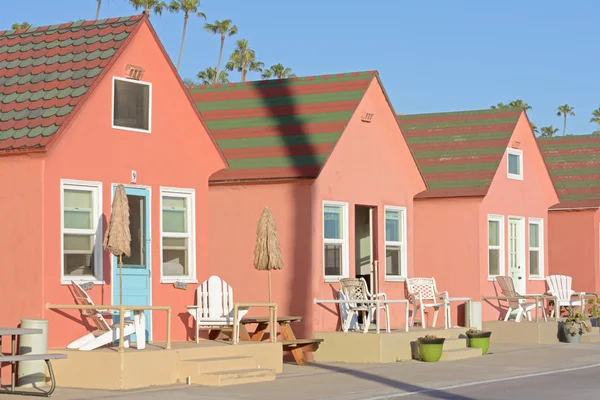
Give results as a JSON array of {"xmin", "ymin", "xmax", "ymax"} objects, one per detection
[{"xmin": 397, "ymin": 108, "xmax": 523, "ymax": 198}]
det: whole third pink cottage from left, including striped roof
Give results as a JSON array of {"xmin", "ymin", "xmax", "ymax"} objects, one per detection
[{"xmin": 398, "ymin": 109, "xmax": 558, "ymax": 325}]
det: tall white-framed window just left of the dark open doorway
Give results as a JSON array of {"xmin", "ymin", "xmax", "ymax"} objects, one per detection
[{"xmin": 323, "ymin": 201, "xmax": 349, "ymax": 282}]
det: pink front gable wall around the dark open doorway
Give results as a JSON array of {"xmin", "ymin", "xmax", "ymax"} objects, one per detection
[{"xmin": 311, "ymin": 80, "xmax": 425, "ymax": 330}]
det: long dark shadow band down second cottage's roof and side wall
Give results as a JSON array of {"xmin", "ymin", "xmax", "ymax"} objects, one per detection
[{"xmin": 258, "ymin": 78, "xmax": 318, "ymax": 346}]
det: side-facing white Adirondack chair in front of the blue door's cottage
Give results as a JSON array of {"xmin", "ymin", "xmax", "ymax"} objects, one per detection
[{"xmin": 67, "ymin": 282, "xmax": 146, "ymax": 351}]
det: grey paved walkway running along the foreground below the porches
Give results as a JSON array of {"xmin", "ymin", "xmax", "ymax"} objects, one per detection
[{"xmin": 10, "ymin": 344, "xmax": 600, "ymax": 400}]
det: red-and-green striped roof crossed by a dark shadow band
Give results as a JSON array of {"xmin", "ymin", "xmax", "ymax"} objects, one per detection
[{"xmin": 190, "ymin": 72, "xmax": 377, "ymax": 181}]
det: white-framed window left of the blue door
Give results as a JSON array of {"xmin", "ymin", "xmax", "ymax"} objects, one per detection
[{"xmin": 60, "ymin": 179, "xmax": 104, "ymax": 284}]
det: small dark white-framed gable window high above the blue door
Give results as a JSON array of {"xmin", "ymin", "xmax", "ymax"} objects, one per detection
[{"xmin": 112, "ymin": 77, "xmax": 152, "ymax": 133}]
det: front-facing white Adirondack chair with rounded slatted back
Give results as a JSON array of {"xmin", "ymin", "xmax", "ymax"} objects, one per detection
[{"xmin": 187, "ymin": 275, "xmax": 248, "ymax": 343}]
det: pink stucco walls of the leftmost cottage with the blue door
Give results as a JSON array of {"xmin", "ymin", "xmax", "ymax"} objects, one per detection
[{"xmin": 0, "ymin": 23, "xmax": 225, "ymax": 347}]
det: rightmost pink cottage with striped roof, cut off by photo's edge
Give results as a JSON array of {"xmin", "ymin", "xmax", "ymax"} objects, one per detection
[{"xmin": 538, "ymin": 135, "xmax": 600, "ymax": 292}]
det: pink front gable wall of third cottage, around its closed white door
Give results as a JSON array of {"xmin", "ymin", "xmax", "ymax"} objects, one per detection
[{"xmin": 479, "ymin": 113, "xmax": 558, "ymax": 319}]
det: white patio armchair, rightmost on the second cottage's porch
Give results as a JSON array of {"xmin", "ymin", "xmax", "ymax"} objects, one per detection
[{"xmin": 406, "ymin": 278, "xmax": 451, "ymax": 328}]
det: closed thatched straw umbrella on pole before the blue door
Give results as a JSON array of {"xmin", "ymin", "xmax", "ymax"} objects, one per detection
[{"xmin": 103, "ymin": 185, "xmax": 131, "ymax": 352}]
